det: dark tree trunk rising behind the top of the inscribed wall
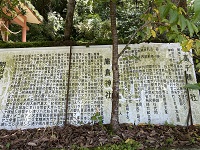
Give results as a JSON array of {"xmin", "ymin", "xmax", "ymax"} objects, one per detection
[{"xmin": 64, "ymin": 0, "xmax": 76, "ymax": 40}]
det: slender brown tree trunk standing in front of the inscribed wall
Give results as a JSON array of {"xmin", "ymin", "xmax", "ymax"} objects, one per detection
[{"xmin": 110, "ymin": 0, "xmax": 119, "ymax": 132}]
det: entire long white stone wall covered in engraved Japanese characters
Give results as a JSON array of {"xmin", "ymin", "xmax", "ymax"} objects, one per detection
[{"xmin": 0, "ymin": 43, "xmax": 200, "ymax": 129}]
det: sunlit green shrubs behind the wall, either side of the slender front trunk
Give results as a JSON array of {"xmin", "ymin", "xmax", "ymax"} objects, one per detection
[{"xmin": 73, "ymin": 0, "xmax": 143, "ymax": 44}]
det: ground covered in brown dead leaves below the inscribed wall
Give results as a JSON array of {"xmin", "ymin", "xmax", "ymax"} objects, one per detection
[{"xmin": 0, "ymin": 124, "xmax": 200, "ymax": 150}]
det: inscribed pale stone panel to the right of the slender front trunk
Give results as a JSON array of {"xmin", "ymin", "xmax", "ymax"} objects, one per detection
[{"xmin": 119, "ymin": 43, "xmax": 200, "ymax": 125}]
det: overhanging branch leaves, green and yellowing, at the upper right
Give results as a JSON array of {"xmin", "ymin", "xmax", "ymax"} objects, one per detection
[{"xmin": 139, "ymin": 0, "xmax": 200, "ymax": 52}]
